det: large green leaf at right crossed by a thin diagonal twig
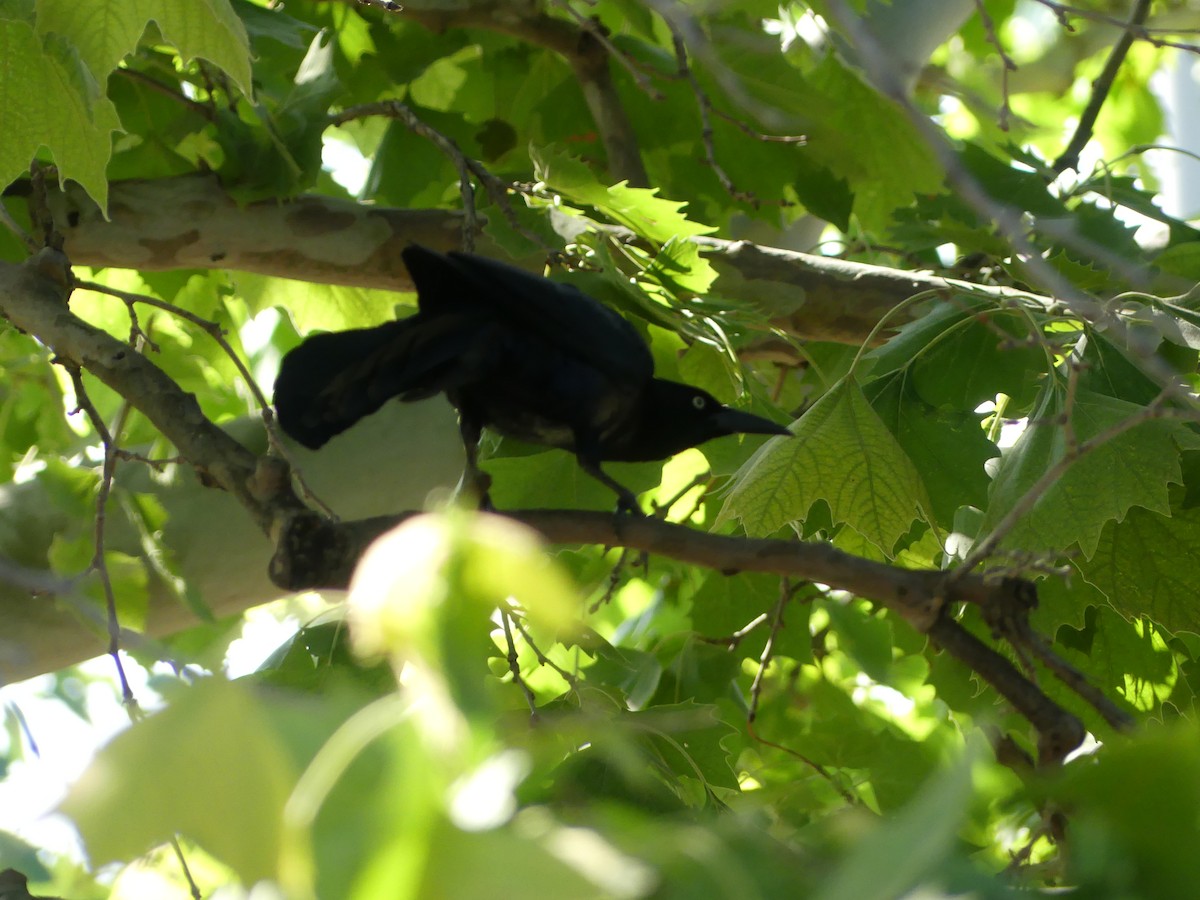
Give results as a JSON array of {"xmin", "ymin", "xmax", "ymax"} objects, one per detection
[{"xmin": 980, "ymin": 388, "xmax": 1195, "ymax": 558}]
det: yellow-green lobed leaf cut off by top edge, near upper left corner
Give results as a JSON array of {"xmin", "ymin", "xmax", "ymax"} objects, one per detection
[{"xmin": 37, "ymin": 0, "xmax": 251, "ymax": 94}]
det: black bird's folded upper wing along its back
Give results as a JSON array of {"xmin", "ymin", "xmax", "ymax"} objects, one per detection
[{"xmin": 403, "ymin": 245, "xmax": 654, "ymax": 386}]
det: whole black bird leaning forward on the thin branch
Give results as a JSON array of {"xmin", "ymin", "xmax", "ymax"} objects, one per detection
[{"xmin": 275, "ymin": 245, "xmax": 788, "ymax": 511}]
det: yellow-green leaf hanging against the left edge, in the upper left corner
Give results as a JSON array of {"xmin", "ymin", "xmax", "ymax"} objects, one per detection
[{"xmin": 0, "ymin": 19, "xmax": 121, "ymax": 208}]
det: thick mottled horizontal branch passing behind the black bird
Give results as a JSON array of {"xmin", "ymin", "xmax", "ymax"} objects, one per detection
[{"xmin": 21, "ymin": 175, "xmax": 1051, "ymax": 348}]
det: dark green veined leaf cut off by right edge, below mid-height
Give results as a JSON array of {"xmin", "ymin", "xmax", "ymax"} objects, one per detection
[{"xmin": 1079, "ymin": 508, "xmax": 1200, "ymax": 634}]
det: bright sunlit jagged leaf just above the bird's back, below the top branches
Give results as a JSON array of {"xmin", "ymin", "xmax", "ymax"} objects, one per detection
[{"xmin": 533, "ymin": 152, "xmax": 716, "ymax": 244}]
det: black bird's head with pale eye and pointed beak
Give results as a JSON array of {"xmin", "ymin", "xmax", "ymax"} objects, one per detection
[{"xmin": 626, "ymin": 378, "xmax": 791, "ymax": 460}]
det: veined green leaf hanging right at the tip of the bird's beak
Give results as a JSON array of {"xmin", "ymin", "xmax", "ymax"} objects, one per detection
[{"xmin": 718, "ymin": 377, "xmax": 930, "ymax": 554}]
